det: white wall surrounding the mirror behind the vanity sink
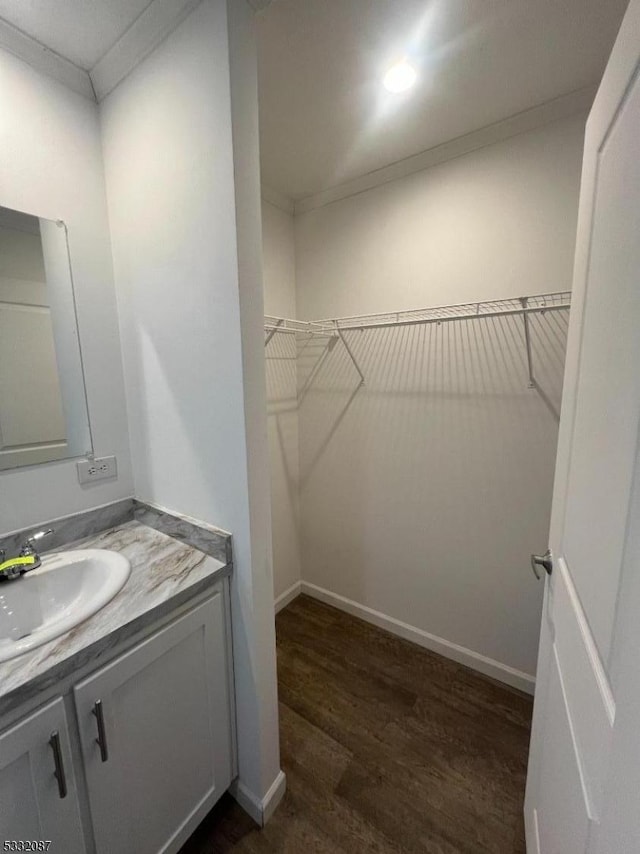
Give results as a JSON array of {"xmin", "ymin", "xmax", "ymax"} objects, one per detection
[{"xmin": 0, "ymin": 50, "xmax": 133, "ymax": 532}]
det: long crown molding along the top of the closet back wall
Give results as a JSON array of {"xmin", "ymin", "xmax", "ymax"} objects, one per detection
[{"xmin": 294, "ymin": 85, "xmax": 597, "ymax": 216}]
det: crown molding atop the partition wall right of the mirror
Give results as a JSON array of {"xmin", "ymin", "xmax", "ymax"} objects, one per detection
[{"xmin": 89, "ymin": 0, "xmax": 201, "ymax": 101}]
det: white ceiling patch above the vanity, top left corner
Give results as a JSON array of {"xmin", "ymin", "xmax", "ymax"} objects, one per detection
[{"xmin": 0, "ymin": 0, "xmax": 151, "ymax": 71}]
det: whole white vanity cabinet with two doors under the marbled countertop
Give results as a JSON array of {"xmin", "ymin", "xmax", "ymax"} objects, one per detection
[{"xmin": 0, "ymin": 578, "xmax": 235, "ymax": 854}]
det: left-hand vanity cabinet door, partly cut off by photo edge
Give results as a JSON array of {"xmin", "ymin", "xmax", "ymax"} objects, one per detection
[{"xmin": 0, "ymin": 699, "xmax": 86, "ymax": 854}]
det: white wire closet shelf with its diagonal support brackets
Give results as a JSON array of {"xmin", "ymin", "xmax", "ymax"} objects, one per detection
[{"xmin": 264, "ymin": 291, "xmax": 571, "ymax": 388}]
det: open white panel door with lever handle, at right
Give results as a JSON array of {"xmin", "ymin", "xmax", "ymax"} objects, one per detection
[{"xmin": 525, "ymin": 0, "xmax": 640, "ymax": 854}]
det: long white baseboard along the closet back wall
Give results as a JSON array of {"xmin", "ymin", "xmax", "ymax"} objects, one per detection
[{"xmin": 300, "ymin": 581, "xmax": 536, "ymax": 694}]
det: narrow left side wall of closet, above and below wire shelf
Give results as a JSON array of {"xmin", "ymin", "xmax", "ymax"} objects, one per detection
[{"xmin": 262, "ymin": 199, "xmax": 300, "ymax": 598}]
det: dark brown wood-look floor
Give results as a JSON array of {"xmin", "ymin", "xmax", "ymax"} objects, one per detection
[{"xmin": 181, "ymin": 596, "xmax": 532, "ymax": 854}]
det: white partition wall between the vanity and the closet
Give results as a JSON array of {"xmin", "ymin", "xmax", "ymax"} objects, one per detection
[{"xmin": 101, "ymin": 0, "xmax": 279, "ymax": 799}]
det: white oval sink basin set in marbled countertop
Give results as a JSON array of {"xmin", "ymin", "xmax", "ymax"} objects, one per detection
[{"xmin": 0, "ymin": 549, "xmax": 131, "ymax": 661}]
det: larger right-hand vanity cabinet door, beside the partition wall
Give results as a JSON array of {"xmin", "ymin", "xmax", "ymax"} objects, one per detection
[{"xmin": 74, "ymin": 592, "xmax": 232, "ymax": 854}]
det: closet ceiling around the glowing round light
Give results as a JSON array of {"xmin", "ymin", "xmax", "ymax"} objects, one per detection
[{"xmin": 258, "ymin": 0, "xmax": 627, "ymax": 200}]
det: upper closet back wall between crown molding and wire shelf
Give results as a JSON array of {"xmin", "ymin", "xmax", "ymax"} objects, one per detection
[{"xmin": 295, "ymin": 117, "xmax": 586, "ymax": 319}]
